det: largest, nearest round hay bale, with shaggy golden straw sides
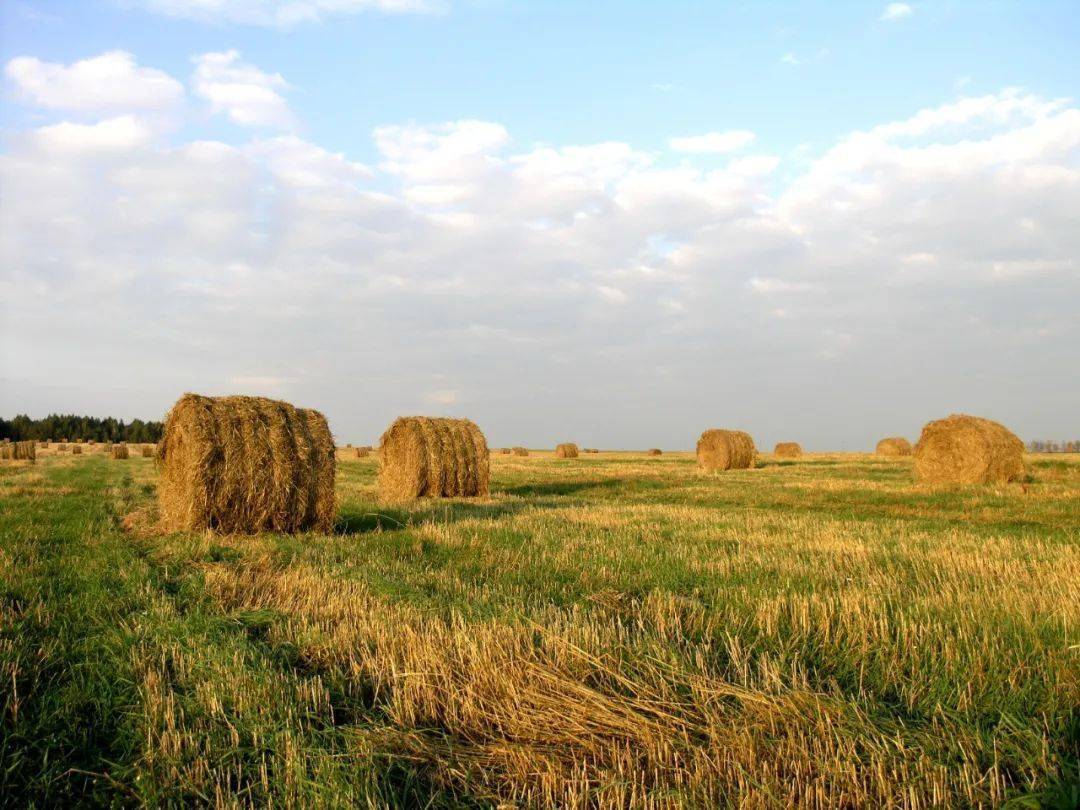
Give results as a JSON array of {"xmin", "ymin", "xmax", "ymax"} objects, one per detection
[{"xmin": 158, "ymin": 393, "xmax": 336, "ymax": 534}]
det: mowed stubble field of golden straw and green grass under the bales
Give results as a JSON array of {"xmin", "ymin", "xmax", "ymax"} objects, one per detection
[{"xmin": 0, "ymin": 448, "xmax": 1080, "ymax": 808}]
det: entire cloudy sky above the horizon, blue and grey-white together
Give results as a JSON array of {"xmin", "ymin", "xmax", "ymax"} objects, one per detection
[{"xmin": 0, "ymin": 0, "xmax": 1080, "ymax": 449}]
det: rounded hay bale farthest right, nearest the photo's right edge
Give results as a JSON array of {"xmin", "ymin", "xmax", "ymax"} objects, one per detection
[{"xmin": 915, "ymin": 414, "xmax": 1027, "ymax": 484}]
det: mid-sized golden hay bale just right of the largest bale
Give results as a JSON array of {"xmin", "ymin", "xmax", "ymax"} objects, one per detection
[{"xmin": 379, "ymin": 416, "xmax": 490, "ymax": 501}]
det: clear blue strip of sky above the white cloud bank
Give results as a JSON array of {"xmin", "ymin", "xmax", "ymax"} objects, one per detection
[{"xmin": 10, "ymin": 0, "xmax": 1080, "ymax": 162}]
